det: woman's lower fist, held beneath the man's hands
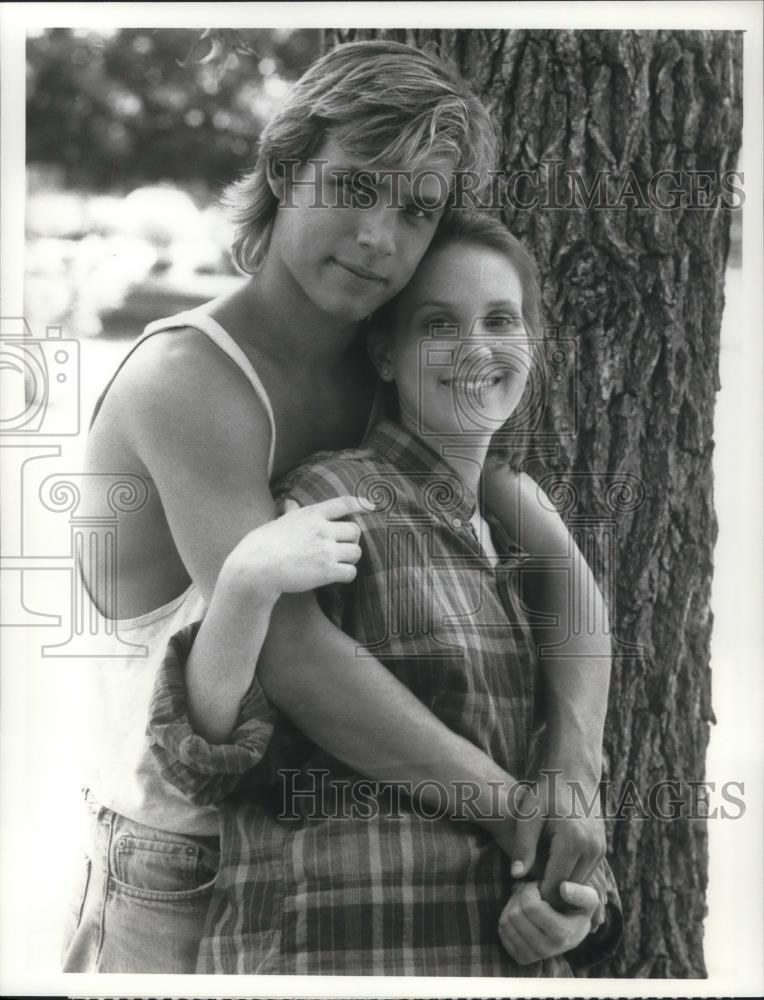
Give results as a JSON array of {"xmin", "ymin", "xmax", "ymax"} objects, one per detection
[{"xmin": 499, "ymin": 882, "xmax": 600, "ymax": 965}]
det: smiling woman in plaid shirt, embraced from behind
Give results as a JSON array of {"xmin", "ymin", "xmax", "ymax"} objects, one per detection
[{"xmin": 151, "ymin": 214, "xmax": 620, "ymax": 976}]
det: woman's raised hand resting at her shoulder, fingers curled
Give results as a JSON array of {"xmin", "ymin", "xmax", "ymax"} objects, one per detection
[{"xmin": 221, "ymin": 496, "xmax": 368, "ymax": 602}]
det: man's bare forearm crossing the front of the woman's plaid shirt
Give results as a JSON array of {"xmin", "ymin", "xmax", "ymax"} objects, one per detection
[{"xmin": 257, "ymin": 594, "xmax": 516, "ymax": 832}]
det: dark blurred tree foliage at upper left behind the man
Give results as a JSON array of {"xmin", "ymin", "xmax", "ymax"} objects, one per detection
[{"xmin": 27, "ymin": 28, "xmax": 320, "ymax": 191}]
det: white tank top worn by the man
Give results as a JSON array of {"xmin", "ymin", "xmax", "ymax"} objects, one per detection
[{"xmin": 83, "ymin": 309, "xmax": 276, "ymax": 834}]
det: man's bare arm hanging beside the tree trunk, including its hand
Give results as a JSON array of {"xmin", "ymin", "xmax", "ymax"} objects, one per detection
[{"xmin": 484, "ymin": 463, "xmax": 610, "ymax": 901}]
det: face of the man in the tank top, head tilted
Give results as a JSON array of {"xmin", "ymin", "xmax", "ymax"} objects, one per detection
[{"xmin": 268, "ymin": 137, "xmax": 453, "ymax": 321}]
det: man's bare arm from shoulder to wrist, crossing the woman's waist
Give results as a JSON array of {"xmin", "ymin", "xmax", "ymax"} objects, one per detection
[{"xmin": 122, "ymin": 332, "xmax": 514, "ymax": 849}]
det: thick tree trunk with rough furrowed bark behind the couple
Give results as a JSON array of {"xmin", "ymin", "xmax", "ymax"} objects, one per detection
[{"xmin": 324, "ymin": 29, "xmax": 742, "ymax": 977}]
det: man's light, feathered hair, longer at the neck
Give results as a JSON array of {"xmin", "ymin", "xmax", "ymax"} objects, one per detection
[{"xmin": 223, "ymin": 40, "xmax": 499, "ymax": 274}]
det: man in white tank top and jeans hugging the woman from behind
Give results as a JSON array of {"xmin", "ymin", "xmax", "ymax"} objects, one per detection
[{"xmin": 64, "ymin": 42, "xmax": 608, "ymax": 972}]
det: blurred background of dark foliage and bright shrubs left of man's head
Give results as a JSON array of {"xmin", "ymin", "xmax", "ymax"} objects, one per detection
[{"xmin": 25, "ymin": 28, "xmax": 320, "ymax": 338}]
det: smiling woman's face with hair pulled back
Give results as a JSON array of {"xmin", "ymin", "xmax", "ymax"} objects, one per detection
[{"xmin": 389, "ymin": 242, "xmax": 531, "ymax": 436}]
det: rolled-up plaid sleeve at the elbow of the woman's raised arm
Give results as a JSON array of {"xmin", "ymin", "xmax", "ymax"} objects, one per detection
[{"xmin": 148, "ymin": 622, "xmax": 278, "ymax": 805}]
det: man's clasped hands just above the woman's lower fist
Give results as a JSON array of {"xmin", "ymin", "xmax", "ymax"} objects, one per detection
[{"xmin": 510, "ymin": 770, "xmax": 605, "ymax": 908}]
